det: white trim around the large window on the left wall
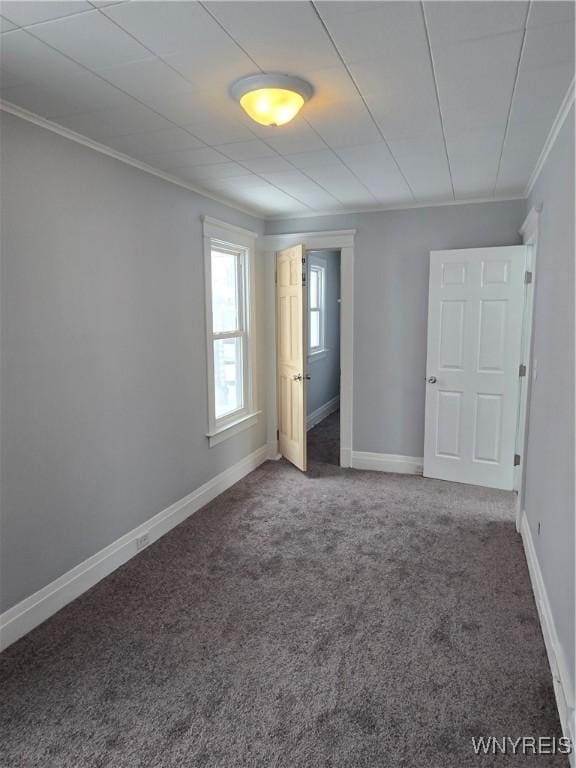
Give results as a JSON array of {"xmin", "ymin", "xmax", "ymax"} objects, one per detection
[{"xmin": 203, "ymin": 216, "xmax": 261, "ymax": 447}]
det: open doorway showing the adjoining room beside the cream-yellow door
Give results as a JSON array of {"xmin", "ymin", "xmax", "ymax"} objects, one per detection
[{"xmin": 306, "ymin": 250, "xmax": 341, "ymax": 466}]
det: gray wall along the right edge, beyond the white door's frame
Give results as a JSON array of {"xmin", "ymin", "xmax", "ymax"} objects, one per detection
[{"xmin": 524, "ymin": 107, "xmax": 576, "ymax": 681}]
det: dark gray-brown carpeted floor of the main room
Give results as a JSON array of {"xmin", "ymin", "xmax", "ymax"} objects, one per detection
[{"xmin": 0, "ymin": 416, "xmax": 567, "ymax": 768}]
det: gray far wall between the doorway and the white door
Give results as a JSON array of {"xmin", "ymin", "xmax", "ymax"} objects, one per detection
[{"xmin": 266, "ymin": 200, "xmax": 526, "ymax": 456}]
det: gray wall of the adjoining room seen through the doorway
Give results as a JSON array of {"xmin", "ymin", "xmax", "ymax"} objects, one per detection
[{"xmin": 308, "ymin": 251, "xmax": 340, "ymax": 414}]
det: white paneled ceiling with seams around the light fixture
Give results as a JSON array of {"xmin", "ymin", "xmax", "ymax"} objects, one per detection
[{"xmin": 0, "ymin": 0, "xmax": 574, "ymax": 216}]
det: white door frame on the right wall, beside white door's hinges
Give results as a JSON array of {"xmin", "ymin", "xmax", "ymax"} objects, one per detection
[{"xmin": 515, "ymin": 205, "xmax": 542, "ymax": 532}]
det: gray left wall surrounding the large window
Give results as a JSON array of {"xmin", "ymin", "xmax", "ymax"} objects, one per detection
[{"xmin": 0, "ymin": 114, "xmax": 265, "ymax": 610}]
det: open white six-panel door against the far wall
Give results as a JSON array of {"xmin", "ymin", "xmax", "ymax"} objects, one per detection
[{"xmin": 424, "ymin": 245, "xmax": 526, "ymax": 490}]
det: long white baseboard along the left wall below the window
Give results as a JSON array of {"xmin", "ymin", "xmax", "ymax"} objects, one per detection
[{"xmin": 0, "ymin": 444, "xmax": 277, "ymax": 650}]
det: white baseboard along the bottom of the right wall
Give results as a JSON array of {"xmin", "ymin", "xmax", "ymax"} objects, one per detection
[{"xmin": 520, "ymin": 511, "xmax": 576, "ymax": 766}]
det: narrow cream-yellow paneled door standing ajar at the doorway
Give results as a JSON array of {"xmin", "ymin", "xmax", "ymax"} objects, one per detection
[{"xmin": 276, "ymin": 245, "xmax": 307, "ymax": 472}]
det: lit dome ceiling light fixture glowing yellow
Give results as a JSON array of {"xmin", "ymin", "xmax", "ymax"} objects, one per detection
[{"xmin": 230, "ymin": 74, "xmax": 314, "ymax": 125}]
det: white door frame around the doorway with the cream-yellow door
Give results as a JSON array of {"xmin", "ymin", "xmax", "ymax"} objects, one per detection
[{"xmin": 259, "ymin": 229, "xmax": 356, "ymax": 467}]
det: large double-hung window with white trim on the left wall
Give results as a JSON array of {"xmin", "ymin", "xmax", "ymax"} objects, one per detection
[{"xmin": 204, "ymin": 218, "xmax": 257, "ymax": 445}]
